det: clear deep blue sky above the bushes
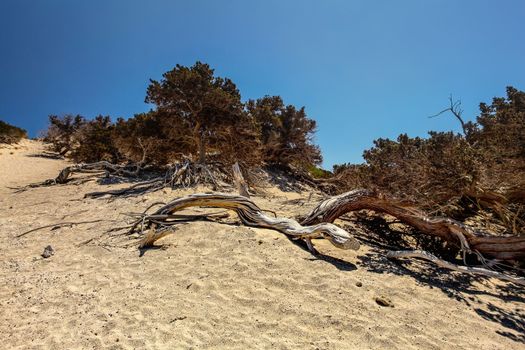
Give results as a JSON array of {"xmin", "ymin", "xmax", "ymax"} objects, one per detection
[{"xmin": 0, "ymin": 0, "xmax": 525, "ymax": 168}]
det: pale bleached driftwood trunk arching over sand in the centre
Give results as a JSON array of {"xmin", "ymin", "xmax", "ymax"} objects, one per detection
[{"xmin": 130, "ymin": 193, "xmax": 360, "ymax": 250}]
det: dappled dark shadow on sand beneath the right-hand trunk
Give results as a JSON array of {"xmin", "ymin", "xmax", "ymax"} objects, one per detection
[{"xmin": 348, "ymin": 217, "xmax": 525, "ymax": 343}]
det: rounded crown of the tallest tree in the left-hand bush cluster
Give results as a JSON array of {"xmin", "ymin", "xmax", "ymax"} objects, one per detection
[{"xmin": 146, "ymin": 62, "xmax": 258, "ymax": 164}]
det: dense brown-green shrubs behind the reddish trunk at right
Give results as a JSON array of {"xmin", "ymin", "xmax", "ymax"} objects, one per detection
[{"xmin": 334, "ymin": 87, "xmax": 525, "ymax": 234}]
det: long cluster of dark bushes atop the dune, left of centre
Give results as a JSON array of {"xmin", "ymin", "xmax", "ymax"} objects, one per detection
[{"xmin": 45, "ymin": 62, "xmax": 321, "ymax": 170}]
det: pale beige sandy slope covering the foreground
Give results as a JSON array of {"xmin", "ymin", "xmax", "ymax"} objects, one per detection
[{"xmin": 0, "ymin": 141, "xmax": 525, "ymax": 349}]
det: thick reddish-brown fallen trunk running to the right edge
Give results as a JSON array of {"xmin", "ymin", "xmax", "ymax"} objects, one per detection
[{"xmin": 301, "ymin": 189, "xmax": 525, "ymax": 261}]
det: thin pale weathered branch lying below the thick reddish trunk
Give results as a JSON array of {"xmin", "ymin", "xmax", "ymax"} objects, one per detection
[{"xmin": 386, "ymin": 250, "xmax": 525, "ymax": 286}]
